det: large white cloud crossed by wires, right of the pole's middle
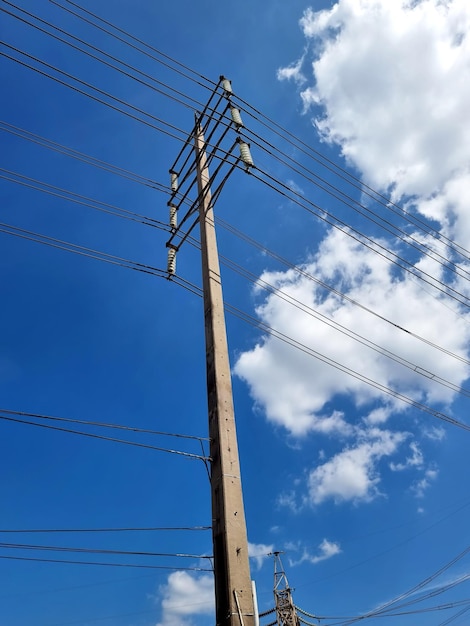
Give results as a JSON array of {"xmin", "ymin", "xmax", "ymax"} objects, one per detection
[{"xmin": 234, "ymin": 231, "xmax": 470, "ymax": 437}]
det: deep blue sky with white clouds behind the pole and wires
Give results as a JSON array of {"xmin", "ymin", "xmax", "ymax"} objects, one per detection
[{"xmin": 0, "ymin": 0, "xmax": 470, "ymax": 626}]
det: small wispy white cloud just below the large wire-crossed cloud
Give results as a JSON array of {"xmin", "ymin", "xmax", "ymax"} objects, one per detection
[{"xmin": 308, "ymin": 429, "xmax": 406, "ymax": 505}]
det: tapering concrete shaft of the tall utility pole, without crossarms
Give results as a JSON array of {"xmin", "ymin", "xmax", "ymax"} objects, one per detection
[{"xmin": 194, "ymin": 122, "xmax": 255, "ymax": 626}]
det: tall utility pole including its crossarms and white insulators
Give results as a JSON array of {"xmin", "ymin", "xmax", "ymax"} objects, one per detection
[{"xmin": 167, "ymin": 77, "xmax": 253, "ymax": 626}]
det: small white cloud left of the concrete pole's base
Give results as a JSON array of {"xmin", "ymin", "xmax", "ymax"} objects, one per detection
[{"xmin": 156, "ymin": 572, "xmax": 214, "ymax": 626}]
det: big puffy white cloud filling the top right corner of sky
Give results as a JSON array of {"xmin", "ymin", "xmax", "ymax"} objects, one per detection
[{"xmin": 278, "ymin": 0, "xmax": 470, "ymax": 242}]
